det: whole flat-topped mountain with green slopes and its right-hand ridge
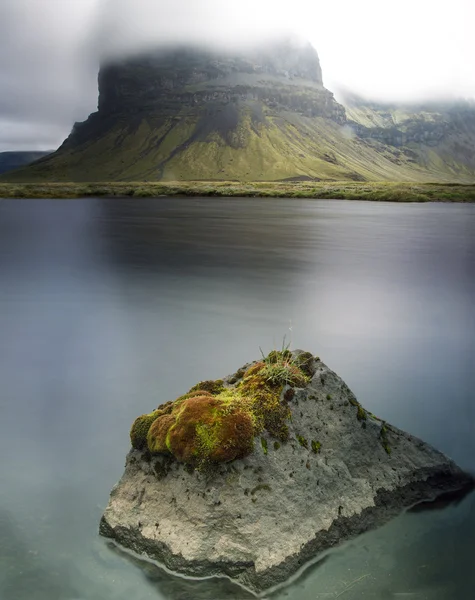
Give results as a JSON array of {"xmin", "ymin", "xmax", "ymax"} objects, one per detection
[{"xmin": 3, "ymin": 39, "xmax": 475, "ymax": 182}]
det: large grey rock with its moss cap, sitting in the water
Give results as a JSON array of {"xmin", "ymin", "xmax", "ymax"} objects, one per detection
[{"xmin": 100, "ymin": 351, "xmax": 473, "ymax": 592}]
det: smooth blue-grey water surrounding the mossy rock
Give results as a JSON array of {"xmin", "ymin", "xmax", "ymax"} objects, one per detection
[{"xmin": 0, "ymin": 199, "xmax": 475, "ymax": 600}]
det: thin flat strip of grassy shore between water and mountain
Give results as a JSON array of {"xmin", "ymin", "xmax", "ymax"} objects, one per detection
[{"xmin": 0, "ymin": 181, "xmax": 475, "ymax": 202}]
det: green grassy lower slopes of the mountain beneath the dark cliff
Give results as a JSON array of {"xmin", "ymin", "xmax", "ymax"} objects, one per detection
[{"xmin": 1, "ymin": 105, "xmax": 475, "ymax": 183}]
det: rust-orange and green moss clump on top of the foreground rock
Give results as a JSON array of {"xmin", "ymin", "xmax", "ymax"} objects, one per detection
[{"xmin": 131, "ymin": 351, "xmax": 308, "ymax": 467}]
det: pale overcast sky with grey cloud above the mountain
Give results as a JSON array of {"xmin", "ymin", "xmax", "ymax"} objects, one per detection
[{"xmin": 0, "ymin": 0, "xmax": 475, "ymax": 151}]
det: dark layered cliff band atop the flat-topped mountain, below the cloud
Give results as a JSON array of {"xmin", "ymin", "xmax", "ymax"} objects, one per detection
[{"xmin": 99, "ymin": 42, "xmax": 345, "ymax": 122}]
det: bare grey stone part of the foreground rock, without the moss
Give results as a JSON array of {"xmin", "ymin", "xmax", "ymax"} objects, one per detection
[{"xmin": 101, "ymin": 360, "xmax": 472, "ymax": 592}]
